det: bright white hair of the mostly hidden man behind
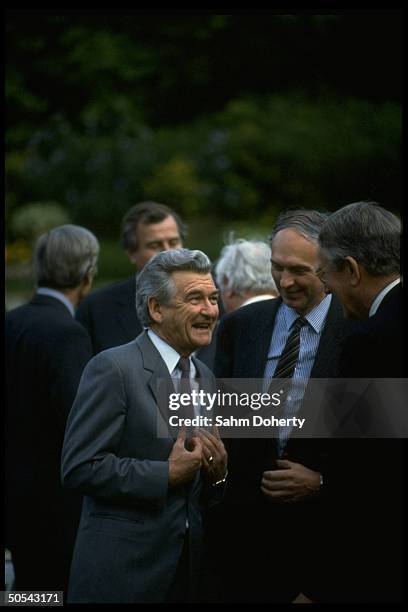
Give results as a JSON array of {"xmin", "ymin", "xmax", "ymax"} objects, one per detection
[{"xmin": 215, "ymin": 238, "xmax": 278, "ymax": 296}]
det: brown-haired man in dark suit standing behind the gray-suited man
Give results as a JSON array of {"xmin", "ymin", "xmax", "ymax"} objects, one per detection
[{"xmin": 77, "ymin": 202, "xmax": 186, "ymax": 355}]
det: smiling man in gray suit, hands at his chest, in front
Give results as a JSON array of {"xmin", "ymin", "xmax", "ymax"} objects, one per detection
[{"xmin": 62, "ymin": 249, "xmax": 227, "ymax": 603}]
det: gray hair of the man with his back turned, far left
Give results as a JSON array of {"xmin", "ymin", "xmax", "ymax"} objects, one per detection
[{"xmin": 34, "ymin": 224, "xmax": 99, "ymax": 290}]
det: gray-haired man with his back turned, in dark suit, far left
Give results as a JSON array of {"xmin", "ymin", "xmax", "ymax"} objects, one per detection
[{"xmin": 5, "ymin": 225, "xmax": 99, "ymax": 591}]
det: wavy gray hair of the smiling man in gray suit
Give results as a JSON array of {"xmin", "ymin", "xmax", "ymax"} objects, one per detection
[{"xmin": 136, "ymin": 249, "xmax": 211, "ymax": 327}]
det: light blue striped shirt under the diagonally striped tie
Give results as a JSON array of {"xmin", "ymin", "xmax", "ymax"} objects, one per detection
[{"xmin": 264, "ymin": 294, "xmax": 332, "ymax": 455}]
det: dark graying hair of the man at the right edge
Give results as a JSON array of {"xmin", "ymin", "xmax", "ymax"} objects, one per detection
[{"xmin": 319, "ymin": 200, "xmax": 401, "ymax": 276}]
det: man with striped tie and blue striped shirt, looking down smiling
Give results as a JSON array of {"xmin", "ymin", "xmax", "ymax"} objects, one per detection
[{"xmin": 213, "ymin": 210, "xmax": 345, "ymax": 602}]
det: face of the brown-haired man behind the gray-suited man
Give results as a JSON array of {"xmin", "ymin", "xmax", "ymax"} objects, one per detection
[{"xmin": 128, "ymin": 216, "xmax": 183, "ymax": 270}]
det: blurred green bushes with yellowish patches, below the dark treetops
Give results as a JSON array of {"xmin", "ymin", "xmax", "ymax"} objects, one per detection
[{"xmin": 6, "ymin": 92, "xmax": 401, "ymax": 244}]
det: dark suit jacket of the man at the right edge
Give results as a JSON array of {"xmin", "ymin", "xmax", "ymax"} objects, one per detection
[{"xmin": 316, "ymin": 285, "xmax": 406, "ymax": 603}]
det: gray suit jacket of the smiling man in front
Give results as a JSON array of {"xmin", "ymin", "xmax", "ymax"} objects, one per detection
[{"xmin": 62, "ymin": 332, "xmax": 214, "ymax": 603}]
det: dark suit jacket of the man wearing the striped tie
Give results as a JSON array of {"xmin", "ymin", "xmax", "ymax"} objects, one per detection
[{"xmin": 211, "ymin": 297, "xmax": 349, "ymax": 603}]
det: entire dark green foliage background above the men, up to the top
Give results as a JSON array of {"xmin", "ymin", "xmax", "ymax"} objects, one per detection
[{"xmin": 6, "ymin": 9, "xmax": 402, "ymax": 286}]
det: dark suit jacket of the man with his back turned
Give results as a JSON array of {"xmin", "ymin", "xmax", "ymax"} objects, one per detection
[{"xmin": 5, "ymin": 295, "xmax": 92, "ymax": 590}]
